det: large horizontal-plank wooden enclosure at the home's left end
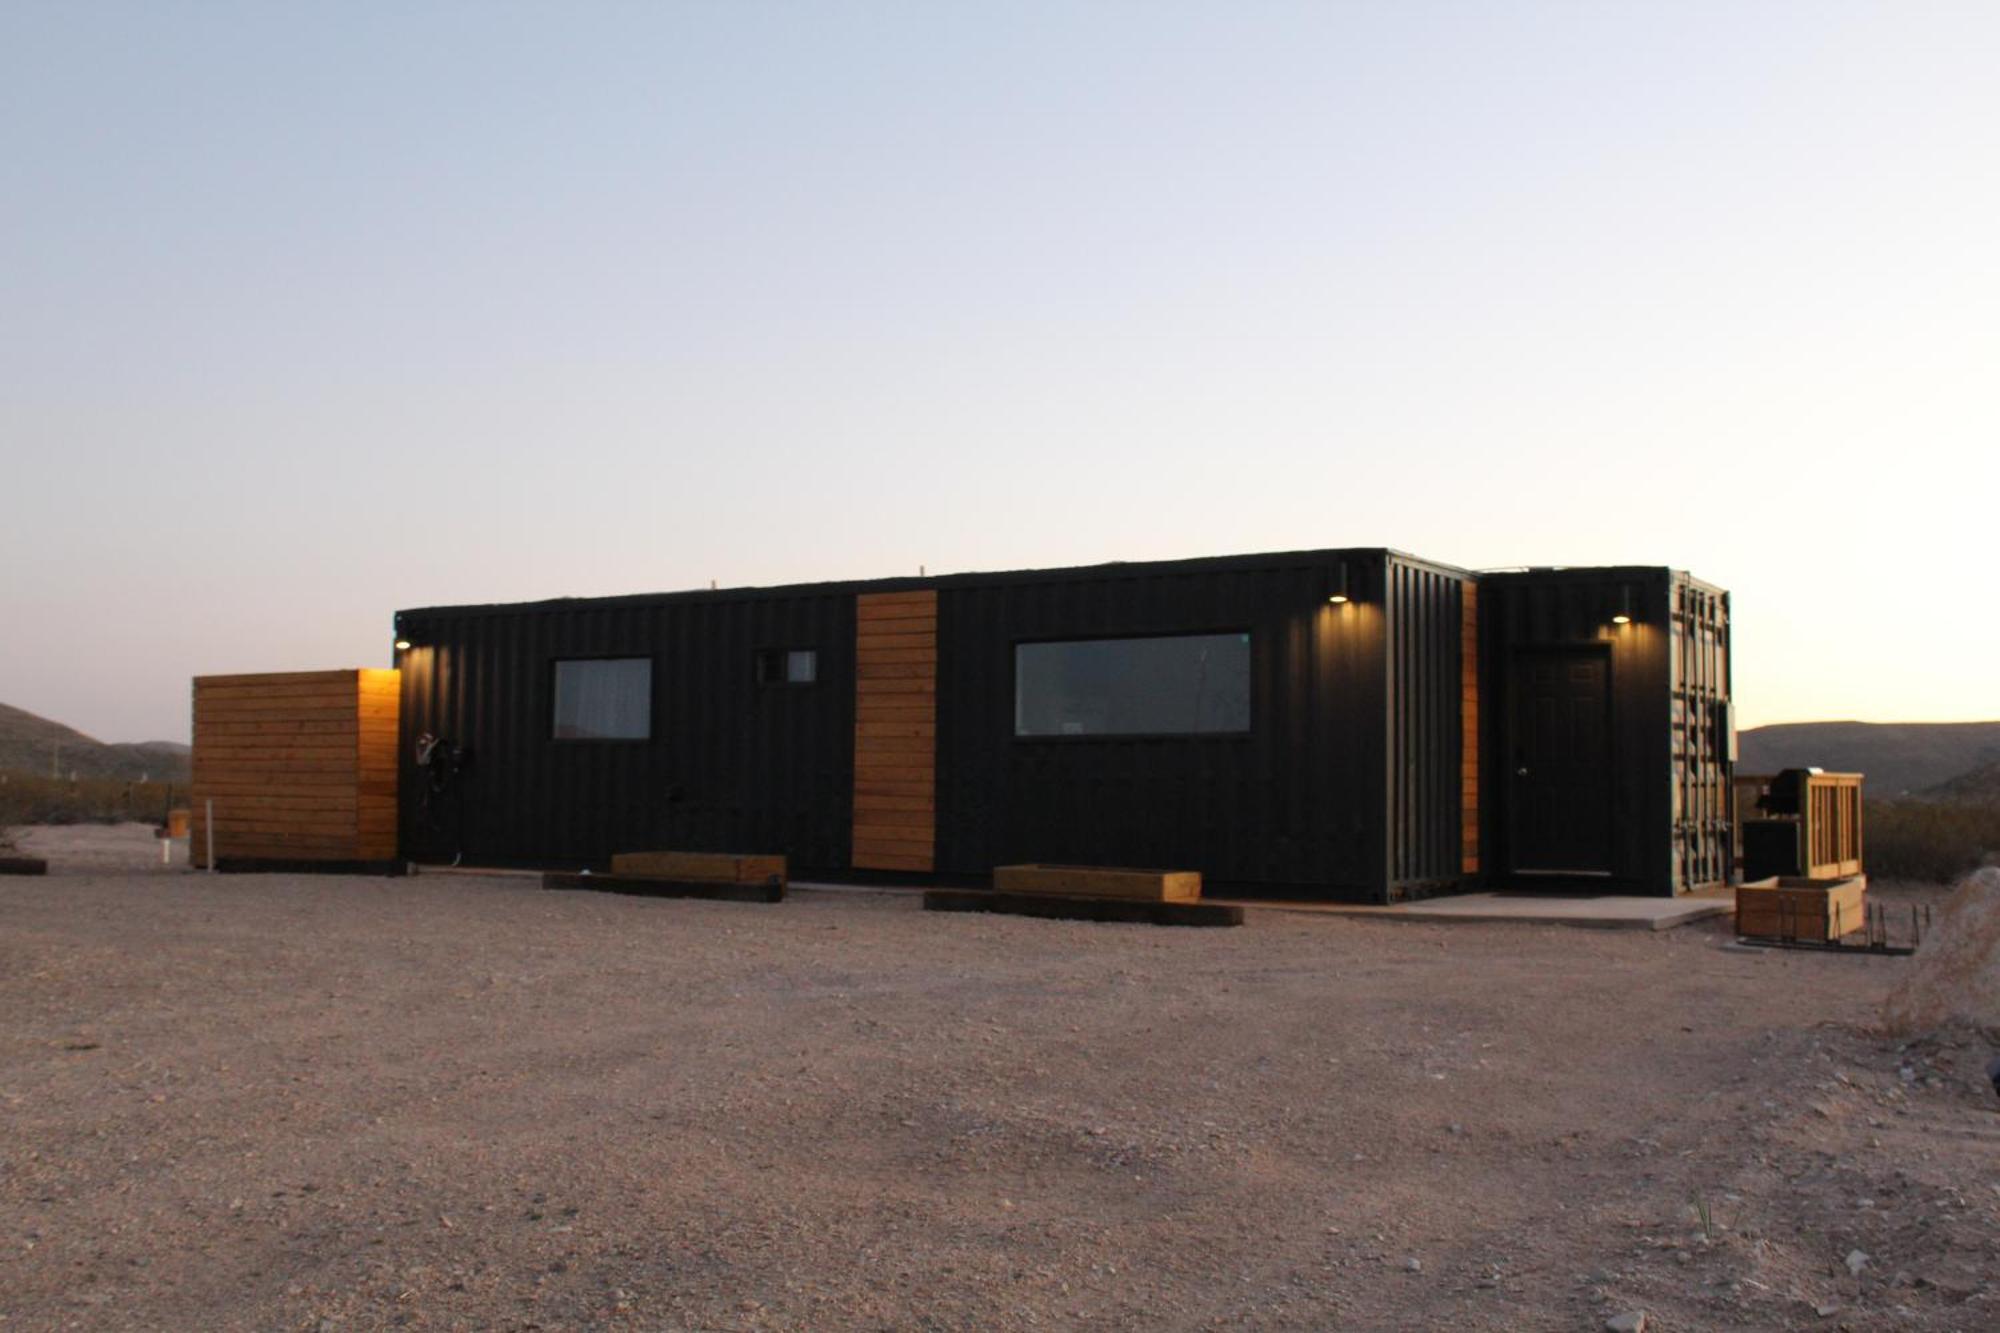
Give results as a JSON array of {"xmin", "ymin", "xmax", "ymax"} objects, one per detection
[{"xmin": 188, "ymin": 669, "xmax": 400, "ymax": 869}]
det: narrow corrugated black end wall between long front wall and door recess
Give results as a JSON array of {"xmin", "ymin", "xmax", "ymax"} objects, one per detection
[{"xmin": 1388, "ymin": 556, "xmax": 1468, "ymax": 897}]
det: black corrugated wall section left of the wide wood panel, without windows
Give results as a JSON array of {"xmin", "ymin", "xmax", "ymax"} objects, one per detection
[{"xmin": 398, "ymin": 588, "xmax": 854, "ymax": 869}]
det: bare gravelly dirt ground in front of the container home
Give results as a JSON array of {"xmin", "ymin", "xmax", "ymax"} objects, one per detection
[{"xmin": 0, "ymin": 829, "xmax": 2000, "ymax": 1333}]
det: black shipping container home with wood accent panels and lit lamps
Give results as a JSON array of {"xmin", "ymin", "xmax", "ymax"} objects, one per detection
[{"xmin": 396, "ymin": 548, "xmax": 1730, "ymax": 903}]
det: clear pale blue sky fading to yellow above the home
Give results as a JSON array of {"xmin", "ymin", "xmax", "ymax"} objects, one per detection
[{"xmin": 0, "ymin": 0, "xmax": 2000, "ymax": 741}]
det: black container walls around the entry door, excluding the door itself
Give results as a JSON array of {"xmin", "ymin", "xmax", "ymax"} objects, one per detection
[{"xmin": 1480, "ymin": 566, "xmax": 1730, "ymax": 895}]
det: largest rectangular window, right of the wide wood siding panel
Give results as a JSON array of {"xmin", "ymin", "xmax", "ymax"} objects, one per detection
[{"xmin": 1014, "ymin": 634, "xmax": 1250, "ymax": 737}]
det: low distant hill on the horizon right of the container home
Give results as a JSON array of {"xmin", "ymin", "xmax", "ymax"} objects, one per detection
[{"xmin": 1736, "ymin": 723, "xmax": 2000, "ymax": 797}]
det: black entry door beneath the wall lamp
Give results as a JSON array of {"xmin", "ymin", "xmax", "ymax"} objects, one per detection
[{"xmin": 1508, "ymin": 648, "xmax": 1612, "ymax": 875}]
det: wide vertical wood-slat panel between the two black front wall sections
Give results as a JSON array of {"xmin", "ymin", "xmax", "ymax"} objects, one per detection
[{"xmin": 854, "ymin": 590, "xmax": 938, "ymax": 871}]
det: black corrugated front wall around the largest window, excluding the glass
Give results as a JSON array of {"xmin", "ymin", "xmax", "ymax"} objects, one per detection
[{"xmin": 938, "ymin": 552, "xmax": 1392, "ymax": 899}]
